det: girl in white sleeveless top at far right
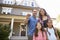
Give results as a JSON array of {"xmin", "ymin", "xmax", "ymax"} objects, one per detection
[{"xmin": 47, "ymin": 20, "xmax": 58, "ymax": 40}]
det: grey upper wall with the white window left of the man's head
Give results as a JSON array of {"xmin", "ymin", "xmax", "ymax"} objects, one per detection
[{"xmin": 11, "ymin": 8, "xmax": 32, "ymax": 15}]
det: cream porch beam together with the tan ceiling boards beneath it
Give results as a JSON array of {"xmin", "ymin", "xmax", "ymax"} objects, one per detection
[{"xmin": 0, "ymin": 14, "xmax": 25, "ymax": 22}]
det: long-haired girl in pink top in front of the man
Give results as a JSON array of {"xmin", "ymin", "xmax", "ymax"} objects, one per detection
[{"xmin": 33, "ymin": 22, "xmax": 47, "ymax": 40}]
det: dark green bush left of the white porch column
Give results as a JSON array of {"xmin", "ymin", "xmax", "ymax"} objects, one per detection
[{"xmin": 0, "ymin": 24, "xmax": 11, "ymax": 40}]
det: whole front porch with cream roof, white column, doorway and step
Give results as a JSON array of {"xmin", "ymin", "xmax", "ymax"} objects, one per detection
[{"xmin": 0, "ymin": 14, "xmax": 28, "ymax": 40}]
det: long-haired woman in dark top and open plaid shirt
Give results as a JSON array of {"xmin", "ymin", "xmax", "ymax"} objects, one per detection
[{"xmin": 38, "ymin": 8, "xmax": 50, "ymax": 28}]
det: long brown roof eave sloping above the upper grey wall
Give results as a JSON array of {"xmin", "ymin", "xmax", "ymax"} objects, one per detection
[{"xmin": 0, "ymin": 4, "xmax": 39, "ymax": 10}]
